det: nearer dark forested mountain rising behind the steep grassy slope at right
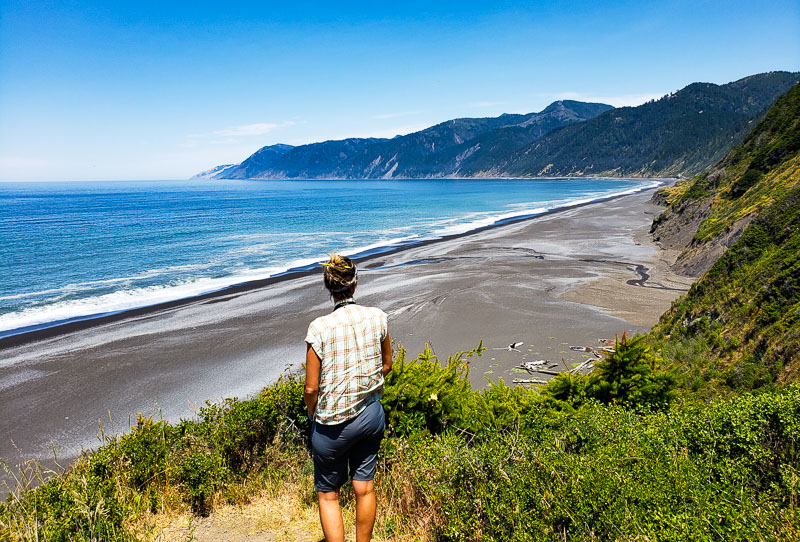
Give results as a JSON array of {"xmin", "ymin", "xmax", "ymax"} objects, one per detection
[{"xmin": 504, "ymin": 72, "xmax": 799, "ymax": 176}]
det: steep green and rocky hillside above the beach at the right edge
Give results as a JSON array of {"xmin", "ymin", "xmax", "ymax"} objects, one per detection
[{"xmin": 652, "ymin": 85, "xmax": 800, "ymax": 389}]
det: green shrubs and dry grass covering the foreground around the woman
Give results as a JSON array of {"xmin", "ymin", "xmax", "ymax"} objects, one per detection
[{"xmin": 0, "ymin": 338, "xmax": 800, "ymax": 541}]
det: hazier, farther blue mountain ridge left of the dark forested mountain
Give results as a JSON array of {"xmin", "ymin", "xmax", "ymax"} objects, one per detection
[{"xmin": 209, "ymin": 100, "xmax": 611, "ymax": 183}]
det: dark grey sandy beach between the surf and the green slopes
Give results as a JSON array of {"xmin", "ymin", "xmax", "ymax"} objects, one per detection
[{"xmin": 0, "ymin": 191, "xmax": 691, "ymax": 486}]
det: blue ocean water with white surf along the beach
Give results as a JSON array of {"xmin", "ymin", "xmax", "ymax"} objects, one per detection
[{"xmin": 0, "ymin": 179, "xmax": 657, "ymax": 336}]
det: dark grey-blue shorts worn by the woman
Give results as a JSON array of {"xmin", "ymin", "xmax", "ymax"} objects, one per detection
[{"xmin": 311, "ymin": 401, "xmax": 386, "ymax": 492}]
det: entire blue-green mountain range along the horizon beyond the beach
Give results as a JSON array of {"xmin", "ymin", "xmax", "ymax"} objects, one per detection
[{"xmin": 201, "ymin": 72, "xmax": 798, "ymax": 179}]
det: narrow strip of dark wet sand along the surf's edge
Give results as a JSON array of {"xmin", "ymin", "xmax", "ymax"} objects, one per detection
[{"xmin": 0, "ymin": 177, "xmax": 676, "ymax": 352}]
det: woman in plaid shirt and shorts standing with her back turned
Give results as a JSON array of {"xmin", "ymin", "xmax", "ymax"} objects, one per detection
[{"xmin": 304, "ymin": 254, "xmax": 392, "ymax": 542}]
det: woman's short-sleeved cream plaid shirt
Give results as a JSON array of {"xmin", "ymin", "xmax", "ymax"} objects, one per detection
[{"xmin": 306, "ymin": 303, "xmax": 387, "ymax": 425}]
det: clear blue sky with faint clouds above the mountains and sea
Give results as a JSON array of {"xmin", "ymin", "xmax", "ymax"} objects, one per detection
[{"xmin": 0, "ymin": 0, "xmax": 800, "ymax": 180}]
